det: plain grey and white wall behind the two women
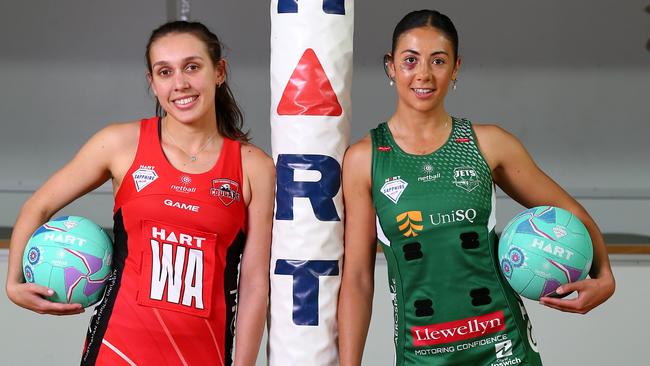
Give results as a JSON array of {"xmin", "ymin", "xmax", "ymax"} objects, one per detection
[{"xmin": 0, "ymin": 0, "xmax": 650, "ymax": 365}]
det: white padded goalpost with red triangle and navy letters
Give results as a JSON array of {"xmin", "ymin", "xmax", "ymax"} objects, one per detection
[{"xmin": 268, "ymin": 0, "xmax": 354, "ymax": 366}]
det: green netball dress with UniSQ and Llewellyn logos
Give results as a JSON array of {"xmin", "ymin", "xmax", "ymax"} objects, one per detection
[{"xmin": 371, "ymin": 118, "xmax": 542, "ymax": 366}]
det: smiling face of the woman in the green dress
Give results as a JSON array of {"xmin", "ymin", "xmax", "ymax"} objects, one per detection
[{"xmin": 387, "ymin": 26, "xmax": 460, "ymax": 113}]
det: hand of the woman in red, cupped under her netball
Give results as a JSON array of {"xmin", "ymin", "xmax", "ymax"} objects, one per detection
[{"xmin": 7, "ymin": 283, "xmax": 84, "ymax": 315}]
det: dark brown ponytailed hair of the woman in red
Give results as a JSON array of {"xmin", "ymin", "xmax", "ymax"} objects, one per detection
[{"xmin": 145, "ymin": 21, "xmax": 250, "ymax": 142}]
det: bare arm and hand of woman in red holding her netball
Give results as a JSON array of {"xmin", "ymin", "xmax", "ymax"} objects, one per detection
[{"xmin": 6, "ymin": 122, "xmax": 130, "ymax": 315}]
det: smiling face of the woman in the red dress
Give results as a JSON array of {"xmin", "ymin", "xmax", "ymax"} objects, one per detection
[{"xmin": 148, "ymin": 33, "xmax": 225, "ymax": 123}]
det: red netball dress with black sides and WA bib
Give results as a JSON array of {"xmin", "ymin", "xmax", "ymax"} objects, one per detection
[{"xmin": 81, "ymin": 118, "xmax": 246, "ymax": 365}]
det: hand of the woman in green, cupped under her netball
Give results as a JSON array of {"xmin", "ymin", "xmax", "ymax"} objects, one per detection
[{"xmin": 539, "ymin": 276, "xmax": 615, "ymax": 314}]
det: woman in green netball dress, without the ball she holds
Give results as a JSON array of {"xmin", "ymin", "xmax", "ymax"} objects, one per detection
[{"xmin": 338, "ymin": 10, "xmax": 615, "ymax": 366}]
